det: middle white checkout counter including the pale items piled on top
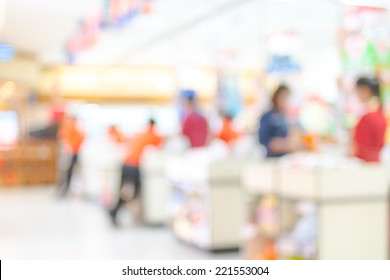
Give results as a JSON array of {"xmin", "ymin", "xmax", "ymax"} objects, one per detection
[{"xmin": 166, "ymin": 138, "xmax": 261, "ymax": 251}]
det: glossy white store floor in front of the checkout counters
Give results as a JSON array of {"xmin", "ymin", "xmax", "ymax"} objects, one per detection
[{"xmin": 0, "ymin": 188, "xmax": 240, "ymax": 259}]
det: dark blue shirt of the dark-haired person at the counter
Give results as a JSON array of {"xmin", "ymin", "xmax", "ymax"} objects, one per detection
[{"xmin": 259, "ymin": 110, "xmax": 288, "ymax": 157}]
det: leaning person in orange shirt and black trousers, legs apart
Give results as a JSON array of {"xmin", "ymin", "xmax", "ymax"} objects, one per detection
[{"xmin": 109, "ymin": 119, "xmax": 163, "ymax": 225}]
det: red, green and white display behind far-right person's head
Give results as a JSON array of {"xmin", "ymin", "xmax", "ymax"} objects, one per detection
[{"xmin": 340, "ymin": 4, "xmax": 390, "ymax": 135}]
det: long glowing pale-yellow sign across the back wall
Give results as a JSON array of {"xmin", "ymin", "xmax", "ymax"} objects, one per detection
[{"xmin": 40, "ymin": 66, "xmax": 175, "ymax": 100}]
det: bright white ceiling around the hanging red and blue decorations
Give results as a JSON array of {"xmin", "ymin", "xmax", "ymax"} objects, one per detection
[{"xmin": 0, "ymin": 0, "xmax": 388, "ymax": 68}]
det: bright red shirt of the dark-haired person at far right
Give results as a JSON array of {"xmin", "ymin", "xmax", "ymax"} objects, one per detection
[{"xmin": 354, "ymin": 111, "xmax": 387, "ymax": 162}]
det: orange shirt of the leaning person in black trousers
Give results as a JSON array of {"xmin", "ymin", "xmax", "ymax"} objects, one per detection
[{"xmin": 125, "ymin": 127, "xmax": 162, "ymax": 166}]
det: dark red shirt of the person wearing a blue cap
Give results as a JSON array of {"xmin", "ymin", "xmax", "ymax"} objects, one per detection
[{"xmin": 183, "ymin": 112, "xmax": 209, "ymax": 148}]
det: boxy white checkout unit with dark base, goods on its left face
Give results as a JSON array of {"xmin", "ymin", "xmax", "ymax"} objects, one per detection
[{"xmin": 172, "ymin": 157, "xmax": 243, "ymax": 251}]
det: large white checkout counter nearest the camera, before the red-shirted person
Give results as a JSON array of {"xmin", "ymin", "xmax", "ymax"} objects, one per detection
[{"xmin": 242, "ymin": 154, "xmax": 390, "ymax": 260}]
